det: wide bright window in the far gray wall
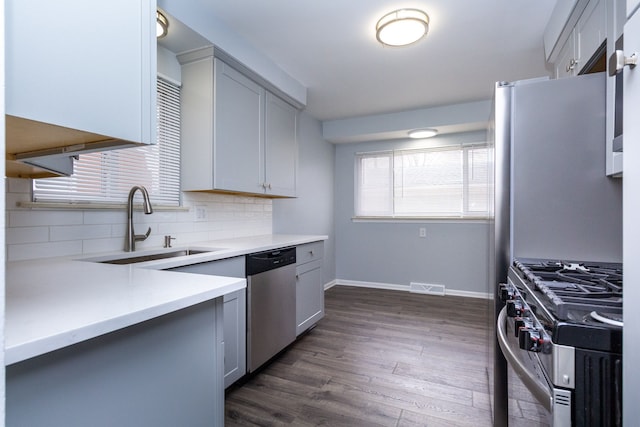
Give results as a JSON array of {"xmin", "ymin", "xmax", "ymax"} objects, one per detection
[{"xmin": 355, "ymin": 144, "xmax": 492, "ymax": 218}]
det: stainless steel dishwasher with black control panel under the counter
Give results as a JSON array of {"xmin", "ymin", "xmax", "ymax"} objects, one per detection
[{"xmin": 246, "ymin": 248, "xmax": 296, "ymax": 372}]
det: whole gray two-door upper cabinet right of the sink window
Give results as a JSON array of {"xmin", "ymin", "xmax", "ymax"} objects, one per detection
[{"xmin": 178, "ymin": 47, "xmax": 297, "ymax": 197}]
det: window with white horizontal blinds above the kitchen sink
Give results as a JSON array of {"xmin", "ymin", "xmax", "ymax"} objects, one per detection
[{"xmin": 33, "ymin": 78, "xmax": 180, "ymax": 206}]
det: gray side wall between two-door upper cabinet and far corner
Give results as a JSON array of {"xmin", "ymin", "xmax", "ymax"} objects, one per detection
[{"xmin": 273, "ymin": 112, "xmax": 336, "ymax": 284}]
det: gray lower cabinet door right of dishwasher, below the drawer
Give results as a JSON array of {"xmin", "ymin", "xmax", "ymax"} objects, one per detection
[{"xmin": 296, "ymin": 260, "xmax": 324, "ymax": 335}]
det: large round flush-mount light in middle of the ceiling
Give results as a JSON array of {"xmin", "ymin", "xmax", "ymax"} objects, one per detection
[{"xmin": 376, "ymin": 9, "xmax": 429, "ymax": 46}]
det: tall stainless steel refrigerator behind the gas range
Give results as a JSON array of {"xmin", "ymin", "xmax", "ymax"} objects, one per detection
[{"xmin": 489, "ymin": 73, "xmax": 622, "ymax": 426}]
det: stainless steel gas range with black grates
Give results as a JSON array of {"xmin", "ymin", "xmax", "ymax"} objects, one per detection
[{"xmin": 497, "ymin": 259, "xmax": 623, "ymax": 426}]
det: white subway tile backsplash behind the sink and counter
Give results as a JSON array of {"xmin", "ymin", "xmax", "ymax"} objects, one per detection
[{"xmin": 5, "ymin": 179, "xmax": 272, "ymax": 261}]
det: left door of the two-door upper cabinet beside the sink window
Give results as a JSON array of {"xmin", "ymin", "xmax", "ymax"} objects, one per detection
[{"xmin": 213, "ymin": 59, "xmax": 265, "ymax": 193}]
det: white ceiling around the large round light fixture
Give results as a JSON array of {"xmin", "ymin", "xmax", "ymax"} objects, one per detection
[{"xmin": 161, "ymin": 0, "xmax": 556, "ymax": 120}]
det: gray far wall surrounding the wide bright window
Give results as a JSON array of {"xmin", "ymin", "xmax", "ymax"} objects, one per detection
[{"xmin": 335, "ymin": 132, "xmax": 489, "ymax": 293}]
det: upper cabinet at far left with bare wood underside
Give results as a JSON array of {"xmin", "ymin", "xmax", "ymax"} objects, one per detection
[{"xmin": 5, "ymin": 0, "xmax": 156, "ymax": 176}]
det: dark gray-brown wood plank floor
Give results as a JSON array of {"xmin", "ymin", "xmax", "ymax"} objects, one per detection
[{"xmin": 225, "ymin": 286, "xmax": 542, "ymax": 427}]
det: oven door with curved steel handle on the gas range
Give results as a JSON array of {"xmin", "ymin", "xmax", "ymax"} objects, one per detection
[{"xmin": 496, "ymin": 307, "xmax": 571, "ymax": 427}]
